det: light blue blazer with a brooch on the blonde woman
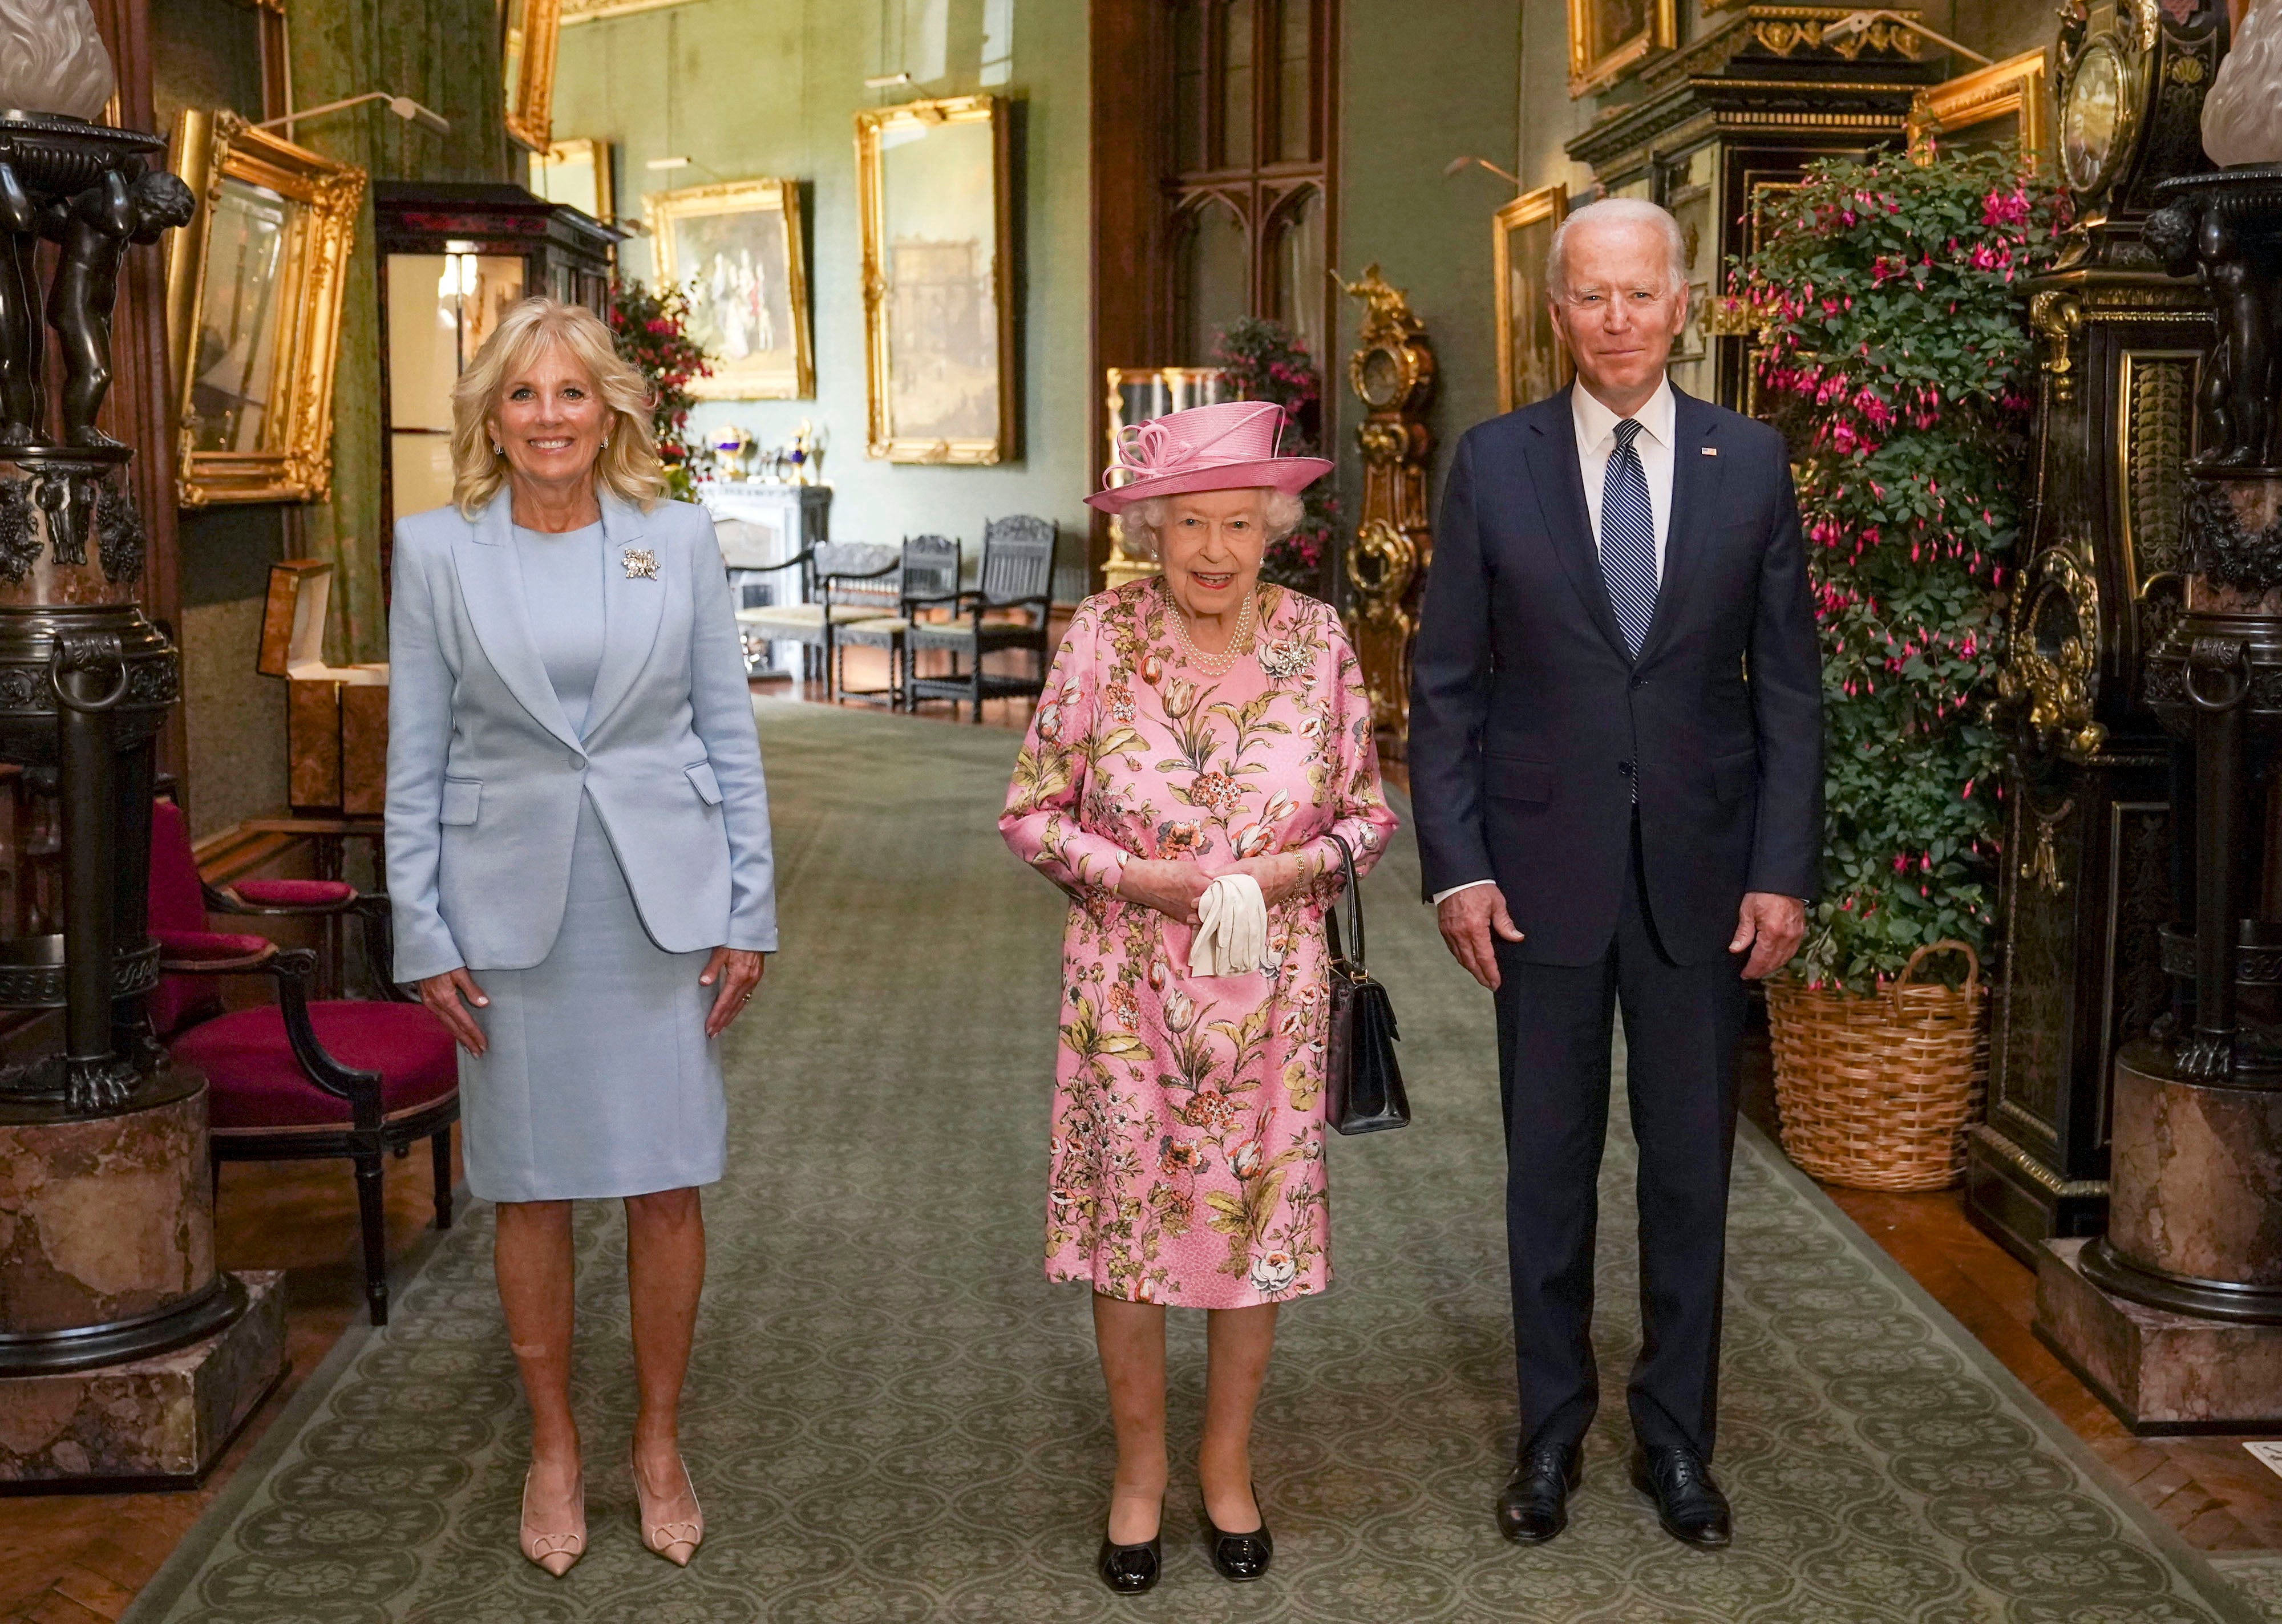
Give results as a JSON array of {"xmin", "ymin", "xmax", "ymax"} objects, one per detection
[{"xmin": 388, "ymin": 491, "xmax": 776, "ymax": 983}]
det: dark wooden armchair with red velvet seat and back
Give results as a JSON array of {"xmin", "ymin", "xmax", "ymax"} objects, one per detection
[{"xmin": 151, "ymin": 801, "xmax": 459, "ymax": 1325}]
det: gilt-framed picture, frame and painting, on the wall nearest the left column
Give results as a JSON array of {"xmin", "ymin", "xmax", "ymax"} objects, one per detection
[{"xmin": 167, "ymin": 107, "xmax": 365, "ymax": 507}]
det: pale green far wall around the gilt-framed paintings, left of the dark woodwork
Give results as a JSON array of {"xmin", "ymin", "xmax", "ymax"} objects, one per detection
[{"xmin": 555, "ymin": 0, "xmax": 1100, "ymax": 577}]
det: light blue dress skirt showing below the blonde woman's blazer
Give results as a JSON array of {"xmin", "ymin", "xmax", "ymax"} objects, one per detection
[{"xmin": 459, "ymin": 799, "xmax": 728, "ymax": 1202}]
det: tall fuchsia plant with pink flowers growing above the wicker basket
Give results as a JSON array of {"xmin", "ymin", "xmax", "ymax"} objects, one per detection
[{"xmin": 1732, "ymin": 151, "xmax": 2065, "ymax": 990}]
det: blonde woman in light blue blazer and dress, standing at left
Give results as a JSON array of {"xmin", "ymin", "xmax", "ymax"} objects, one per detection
[{"xmin": 388, "ymin": 299, "xmax": 776, "ymax": 1578}]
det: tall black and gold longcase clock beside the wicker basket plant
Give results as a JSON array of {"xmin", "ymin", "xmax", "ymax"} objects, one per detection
[{"xmin": 1965, "ymin": 0, "xmax": 2227, "ymax": 1266}]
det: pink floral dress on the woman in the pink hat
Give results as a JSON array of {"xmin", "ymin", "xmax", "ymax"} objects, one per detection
[{"xmin": 1000, "ymin": 580, "xmax": 1394, "ymax": 1309}]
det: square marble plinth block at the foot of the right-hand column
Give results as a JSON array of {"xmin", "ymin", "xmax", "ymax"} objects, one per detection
[{"xmin": 2036, "ymin": 1241, "xmax": 2282, "ymax": 1435}]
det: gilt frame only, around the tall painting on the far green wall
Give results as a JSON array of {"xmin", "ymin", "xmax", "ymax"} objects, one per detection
[{"xmin": 856, "ymin": 96, "xmax": 1020, "ymax": 465}]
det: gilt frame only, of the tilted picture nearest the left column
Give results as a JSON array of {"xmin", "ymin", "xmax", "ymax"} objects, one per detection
[{"xmin": 167, "ymin": 107, "xmax": 365, "ymax": 507}]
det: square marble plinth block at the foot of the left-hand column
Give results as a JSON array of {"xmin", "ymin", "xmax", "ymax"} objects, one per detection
[{"xmin": 0, "ymin": 1270, "xmax": 285, "ymax": 1494}]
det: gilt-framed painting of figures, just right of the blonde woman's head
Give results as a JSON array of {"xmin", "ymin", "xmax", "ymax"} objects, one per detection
[{"xmin": 641, "ymin": 180, "xmax": 817, "ymax": 402}]
